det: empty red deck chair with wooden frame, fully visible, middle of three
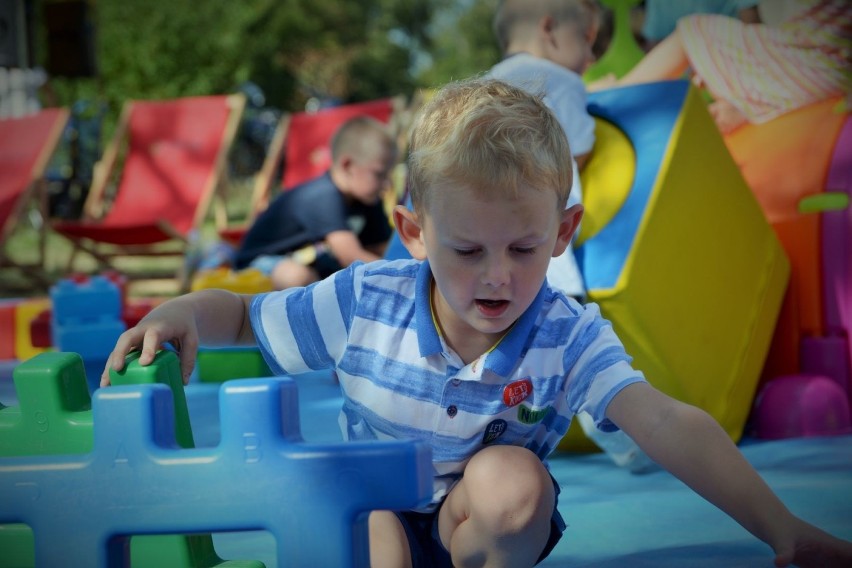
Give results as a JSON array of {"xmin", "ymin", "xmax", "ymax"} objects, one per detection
[{"xmin": 52, "ymin": 95, "xmax": 245, "ymax": 282}]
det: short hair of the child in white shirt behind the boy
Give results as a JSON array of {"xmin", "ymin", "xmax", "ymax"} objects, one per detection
[{"xmin": 493, "ymin": 0, "xmax": 601, "ymax": 54}]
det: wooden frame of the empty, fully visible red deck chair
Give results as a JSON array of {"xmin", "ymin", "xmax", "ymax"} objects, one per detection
[{"xmin": 52, "ymin": 94, "xmax": 246, "ymax": 286}]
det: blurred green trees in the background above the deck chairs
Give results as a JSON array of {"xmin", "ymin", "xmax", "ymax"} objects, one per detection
[{"xmin": 35, "ymin": 0, "xmax": 498, "ymax": 116}]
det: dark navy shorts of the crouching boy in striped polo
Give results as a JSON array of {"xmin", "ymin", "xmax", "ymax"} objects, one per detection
[{"xmin": 396, "ymin": 476, "xmax": 565, "ymax": 568}]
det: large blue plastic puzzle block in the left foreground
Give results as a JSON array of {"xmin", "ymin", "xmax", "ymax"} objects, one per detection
[{"xmin": 0, "ymin": 372, "xmax": 432, "ymax": 567}]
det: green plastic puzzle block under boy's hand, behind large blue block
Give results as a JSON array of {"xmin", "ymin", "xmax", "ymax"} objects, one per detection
[{"xmin": 0, "ymin": 351, "xmax": 263, "ymax": 568}]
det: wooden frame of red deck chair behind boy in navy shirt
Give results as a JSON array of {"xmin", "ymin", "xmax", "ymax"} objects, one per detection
[{"xmin": 219, "ymin": 96, "xmax": 410, "ymax": 245}]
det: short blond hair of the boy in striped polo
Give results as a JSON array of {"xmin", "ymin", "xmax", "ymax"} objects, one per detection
[{"xmin": 408, "ymin": 78, "xmax": 572, "ymax": 215}]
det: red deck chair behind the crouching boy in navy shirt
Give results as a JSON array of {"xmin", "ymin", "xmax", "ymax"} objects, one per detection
[{"xmin": 219, "ymin": 97, "xmax": 405, "ymax": 245}]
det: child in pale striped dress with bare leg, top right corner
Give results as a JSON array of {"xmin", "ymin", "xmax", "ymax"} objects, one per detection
[{"xmin": 589, "ymin": 0, "xmax": 852, "ymax": 133}]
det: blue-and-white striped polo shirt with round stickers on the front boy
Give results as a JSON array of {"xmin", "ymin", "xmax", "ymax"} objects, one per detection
[{"xmin": 251, "ymin": 260, "xmax": 645, "ymax": 508}]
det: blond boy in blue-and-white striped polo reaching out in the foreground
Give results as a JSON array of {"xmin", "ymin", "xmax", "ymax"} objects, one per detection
[{"xmin": 102, "ymin": 80, "xmax": 852, "ymax": 567}]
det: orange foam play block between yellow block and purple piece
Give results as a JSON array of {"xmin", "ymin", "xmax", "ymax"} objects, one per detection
[{"xmin": 724, "ymin": 98, "xmax": 849, "ymax": 380}]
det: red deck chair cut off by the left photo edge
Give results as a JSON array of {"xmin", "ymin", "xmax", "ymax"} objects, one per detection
[{"xmin": 0, "ymin": 108, "xmax": 69, "ymax": 285}]
